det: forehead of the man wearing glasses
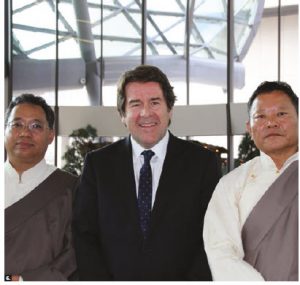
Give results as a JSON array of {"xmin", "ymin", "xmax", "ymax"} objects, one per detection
[{"xmin": 9, "ymin": 103, "xmax": 46, "ymax": 119}]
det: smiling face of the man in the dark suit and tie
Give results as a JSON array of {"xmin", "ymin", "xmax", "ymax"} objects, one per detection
[{"xmin": 122, "ymin": 82, "xmax": 172, "ymax": 148}]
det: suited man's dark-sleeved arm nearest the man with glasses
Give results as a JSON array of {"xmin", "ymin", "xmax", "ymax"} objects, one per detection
[{"xmin": 74, "ymin": 155, "xmax": 111, "ymax": 280}]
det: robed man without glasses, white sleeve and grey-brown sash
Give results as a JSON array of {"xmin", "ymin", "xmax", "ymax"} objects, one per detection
[{"xmin": 204, "ymin": 82, "xmax": 298, "ymax": 281}]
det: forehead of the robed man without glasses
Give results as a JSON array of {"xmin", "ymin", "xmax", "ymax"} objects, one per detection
[{"xmin": 251, "ymin": 90, "xmax": 294, "ymax": 112}]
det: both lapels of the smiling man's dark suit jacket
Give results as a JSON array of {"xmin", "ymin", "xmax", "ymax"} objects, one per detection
[{"xmin": 119, "ymin": 133, "xmax": 188, "ymax": 239}]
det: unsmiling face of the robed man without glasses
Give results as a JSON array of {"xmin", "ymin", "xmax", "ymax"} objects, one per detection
[{"xmin": 247, "ymin": 91, "xmax": 298, "ymax": 157}]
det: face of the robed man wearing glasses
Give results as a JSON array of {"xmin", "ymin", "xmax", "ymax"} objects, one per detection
[{"xmin": 5, "ymin": 103, "xmax": 54, "ymax": 169}]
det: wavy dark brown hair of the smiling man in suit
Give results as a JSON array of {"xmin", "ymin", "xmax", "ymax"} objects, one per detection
[{"xmin": 117, "ymin": 65, "xmax": 176, "ymax": 116}]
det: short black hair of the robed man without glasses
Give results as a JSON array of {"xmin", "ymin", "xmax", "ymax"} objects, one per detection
[{"xmin": 248, "ymin": 81, "xmax": 298, "ymax": 114}]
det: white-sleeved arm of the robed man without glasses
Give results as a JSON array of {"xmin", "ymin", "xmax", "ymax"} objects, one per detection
[{"xmin": 203, "ymin": 177, "xmax": 264, "ymax": 281}]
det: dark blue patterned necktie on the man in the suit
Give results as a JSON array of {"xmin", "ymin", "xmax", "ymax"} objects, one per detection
[{"xmin": 138, "ymin": 150, "xmax": 154, "ymax": 238}]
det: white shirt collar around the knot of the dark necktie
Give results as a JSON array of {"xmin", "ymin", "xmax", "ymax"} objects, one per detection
[{"xmin": 130, "ymin": 131, "xmax": 170, "ymax": 159}]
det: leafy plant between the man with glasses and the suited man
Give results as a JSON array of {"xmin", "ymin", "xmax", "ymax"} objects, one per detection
[{"xmin": 62, "ymin": 125, "xmax": 109, "ymax": 175}]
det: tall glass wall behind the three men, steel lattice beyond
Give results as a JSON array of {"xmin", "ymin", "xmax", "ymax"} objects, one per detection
[{"xmin": 5, "ymin": 0, "xmax": 299, "ymax": 171}]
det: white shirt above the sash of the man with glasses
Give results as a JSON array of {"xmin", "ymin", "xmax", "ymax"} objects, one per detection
[{"xmin": 4, "ymin": 159, "xmax": 56, "ymax": 208}]
